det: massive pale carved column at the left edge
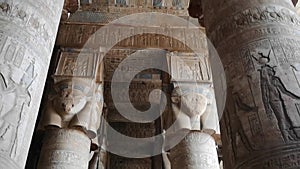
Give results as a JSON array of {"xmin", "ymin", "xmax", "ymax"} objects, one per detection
[{"xmin": 0, "ymin": 0, "xmax": 63, "ymax": 169}]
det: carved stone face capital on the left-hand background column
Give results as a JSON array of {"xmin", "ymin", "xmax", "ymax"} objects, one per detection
[{"xmin": 43, "ymin": 79, "xmax": 103, "ymax": 139}]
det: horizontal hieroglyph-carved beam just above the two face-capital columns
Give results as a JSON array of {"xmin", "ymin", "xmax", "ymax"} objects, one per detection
[{"xmin": 57, "ymin": 22, "xmax": 205, "ymax": 51}]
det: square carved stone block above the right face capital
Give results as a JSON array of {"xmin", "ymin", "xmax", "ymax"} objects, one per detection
[{"xmin": 168, "ymin": 53, "xmax": 212, "ymax": 82}]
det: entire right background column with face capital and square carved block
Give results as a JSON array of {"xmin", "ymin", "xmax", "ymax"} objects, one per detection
[{"xmin": 166, "ymin": 51, "xmax": 219, "ymax": 169}]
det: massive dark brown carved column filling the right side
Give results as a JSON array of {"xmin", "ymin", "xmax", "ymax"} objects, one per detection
[{"xmin": 202, "ymin": 0, "xmax": 300, "ymax": 169}]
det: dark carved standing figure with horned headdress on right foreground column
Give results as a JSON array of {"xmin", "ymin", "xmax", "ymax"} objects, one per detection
[{"xmin": 253, "ymin": 51, "xmax": 300, "ymax": 142}]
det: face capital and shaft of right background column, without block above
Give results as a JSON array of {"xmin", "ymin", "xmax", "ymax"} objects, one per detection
[{"xmin": 170, "ymin": 86, "xmax": 219, "ymax": 169}]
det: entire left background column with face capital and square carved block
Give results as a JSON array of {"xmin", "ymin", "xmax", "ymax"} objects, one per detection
[{"xmin": 38, "ymin": 51, "xmax": 103, "ymax": 169}]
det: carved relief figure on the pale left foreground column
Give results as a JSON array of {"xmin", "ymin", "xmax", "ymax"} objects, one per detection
[{"xmin": 0, "ymin": 64, "xmax": 34, "ymax": 157}]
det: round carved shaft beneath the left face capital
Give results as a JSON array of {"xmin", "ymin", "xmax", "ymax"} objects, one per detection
[{"xmin": 38, "ymin": 129, "xmax": 90, "ymax": 169}]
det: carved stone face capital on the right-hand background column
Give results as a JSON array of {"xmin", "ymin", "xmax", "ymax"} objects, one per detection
[{"xmin": 171, "ymin": 87, "xmax": 219, "ymax": 134}]
